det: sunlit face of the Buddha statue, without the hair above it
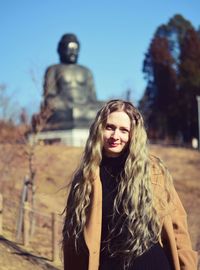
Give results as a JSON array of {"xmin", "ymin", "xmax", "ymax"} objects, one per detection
[{"xmin": 62, "ymin": 42, "xmax": 79, "ymax": 64}]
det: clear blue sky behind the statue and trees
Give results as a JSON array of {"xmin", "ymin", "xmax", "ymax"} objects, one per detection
[{"xmin": 0, "ymin": 0, "xmax": 200, "ymax": 116}]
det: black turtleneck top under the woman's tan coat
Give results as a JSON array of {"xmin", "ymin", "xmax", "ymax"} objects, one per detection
[{"xmin": 99, "ymin": 153, "xmax": 172, "ymax": 270}]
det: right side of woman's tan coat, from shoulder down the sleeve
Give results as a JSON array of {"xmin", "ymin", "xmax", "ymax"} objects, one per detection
[{"xmin": 151, "ymin": 158, "xmax": 197, "ymax": 270}]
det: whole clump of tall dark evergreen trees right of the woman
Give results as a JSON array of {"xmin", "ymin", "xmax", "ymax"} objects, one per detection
[{"xmin": 139, "ymin": 15, "xmax": 200, "ymax": 143}]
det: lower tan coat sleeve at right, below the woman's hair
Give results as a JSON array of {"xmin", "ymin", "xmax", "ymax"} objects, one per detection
[{"xmin": 170, "ymin": 184, "xmax": 197, "ymax": 270}]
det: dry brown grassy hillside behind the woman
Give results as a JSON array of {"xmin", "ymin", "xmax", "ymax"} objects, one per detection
[{"xmin": 0, "ymin": 145, "xmax": 200, "ymax": 269}]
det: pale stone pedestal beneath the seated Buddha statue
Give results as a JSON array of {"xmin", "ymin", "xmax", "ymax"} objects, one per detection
[{"xmin": 29, "ymin": 128, "xmax": 89, "ymax": 147}]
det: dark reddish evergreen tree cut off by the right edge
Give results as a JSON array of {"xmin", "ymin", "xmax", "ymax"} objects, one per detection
[{"xmin": 179, "ymin": 29, "xmax": 200, "ymax": 142}]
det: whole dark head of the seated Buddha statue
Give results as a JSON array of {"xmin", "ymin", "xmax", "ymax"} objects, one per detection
[{"xmin": 57, "ymin": 34, "xmax": 80, "ymax": 64}]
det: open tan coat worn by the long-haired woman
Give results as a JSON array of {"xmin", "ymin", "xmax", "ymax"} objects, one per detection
[{"xmin": 64, "ymin": 159, "xmax": 197, "ymax": 270}]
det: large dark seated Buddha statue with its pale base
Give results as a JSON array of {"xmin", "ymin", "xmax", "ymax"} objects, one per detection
[{"xmin": 32, "ymin": 34, "xmax": 104, "ymax": 145}]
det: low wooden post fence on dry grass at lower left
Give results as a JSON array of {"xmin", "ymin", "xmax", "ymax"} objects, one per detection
[{"xmin": 0, "ymin": 193, "xmax": 63, "ymax": 263}]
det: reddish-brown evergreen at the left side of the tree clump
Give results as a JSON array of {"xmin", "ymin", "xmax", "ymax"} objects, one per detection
[{"xmin": 140, "ymin": 37, "xmax": 176, "ymax": 138}]
